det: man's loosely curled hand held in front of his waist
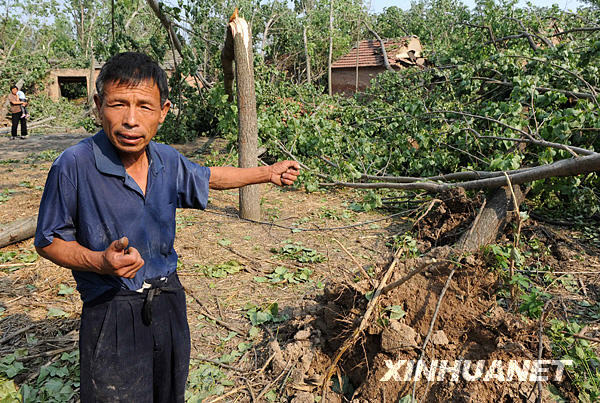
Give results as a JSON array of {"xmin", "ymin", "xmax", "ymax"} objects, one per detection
[{"xmin": 100, "ymin": 237, "xmax": 144, "ymax": 278}]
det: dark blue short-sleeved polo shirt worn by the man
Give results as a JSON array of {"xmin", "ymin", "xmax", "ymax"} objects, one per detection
[{"xmin": 35, "ymin": 131, "xmax": 210, "ymax": 302}]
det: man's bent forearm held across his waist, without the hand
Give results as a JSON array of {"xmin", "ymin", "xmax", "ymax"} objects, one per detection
[{"xmin": 35, "ymin": 237, "xmax": 102, "ymax": 273}]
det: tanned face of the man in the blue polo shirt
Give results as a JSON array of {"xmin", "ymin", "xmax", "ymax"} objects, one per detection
[{"xmin": 94, "ymin": 81, "xmax": 171, "ymax": 155}]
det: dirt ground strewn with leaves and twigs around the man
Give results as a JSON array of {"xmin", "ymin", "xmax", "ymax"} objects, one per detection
[{"xmin": 0, "ymin": 135, "xmax": 600, "ymax": 403}]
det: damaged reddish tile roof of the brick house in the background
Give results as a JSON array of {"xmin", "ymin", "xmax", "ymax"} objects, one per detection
[{"xmin": 331, "ymin": 36, "xmax": 421, "ymax": 69}]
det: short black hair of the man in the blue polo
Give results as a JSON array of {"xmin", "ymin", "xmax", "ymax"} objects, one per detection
[{"xmin": 96, "ymin": 52, "xmax": 169, "ymax": 106}]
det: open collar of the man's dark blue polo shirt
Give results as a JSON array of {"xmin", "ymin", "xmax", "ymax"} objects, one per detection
[{"xmin": 92, "ymin": 130, "xmax": 164, "ymax": 178}]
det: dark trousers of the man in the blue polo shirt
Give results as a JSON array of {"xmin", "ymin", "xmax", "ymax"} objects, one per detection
[{"xmin": 79, "ymin": 275, "xmax": 190, "ymax": 403}]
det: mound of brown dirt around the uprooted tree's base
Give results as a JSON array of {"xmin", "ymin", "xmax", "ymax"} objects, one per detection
[{"xmin": 269, "ymin": 191, "xmax": 574, "ymax": 402}]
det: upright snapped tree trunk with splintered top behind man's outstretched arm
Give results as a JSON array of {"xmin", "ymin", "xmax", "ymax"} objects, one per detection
[{"xmin": 221, "ymin": 8, "xmax": 260, "ymax": 220}]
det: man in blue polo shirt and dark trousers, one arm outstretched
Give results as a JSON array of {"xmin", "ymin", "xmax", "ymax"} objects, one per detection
[{"xmin": 35, "ymin": 52, "xmax": 299, "ymax": 403}]
